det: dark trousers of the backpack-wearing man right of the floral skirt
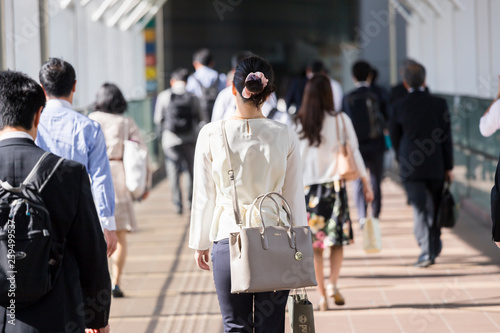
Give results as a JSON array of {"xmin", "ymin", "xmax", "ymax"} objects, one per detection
[{"xmin": 354, "ymin": 152, "xmax": 384, "ymax": 219}]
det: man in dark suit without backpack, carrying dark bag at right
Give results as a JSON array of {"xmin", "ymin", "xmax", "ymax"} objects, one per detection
[{"xmin": 389, "ymin": 63, "xmax": 453, "ymax": 267}]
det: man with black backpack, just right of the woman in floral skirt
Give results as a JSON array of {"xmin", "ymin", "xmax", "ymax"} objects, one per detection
[{"xmin": 342, "ymin": 60, "xmax": 389, "ymax": 227}]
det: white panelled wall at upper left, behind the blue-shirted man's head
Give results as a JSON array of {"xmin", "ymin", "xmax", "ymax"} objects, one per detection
[{"xmin": 0, "ymin": 0, "xmax": 146, "ymax": 107}]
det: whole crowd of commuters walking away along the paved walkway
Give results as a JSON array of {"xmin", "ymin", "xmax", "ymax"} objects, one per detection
[{"xmin": 0, "ymin": 44, "xmax": 484, "ymax": 333}]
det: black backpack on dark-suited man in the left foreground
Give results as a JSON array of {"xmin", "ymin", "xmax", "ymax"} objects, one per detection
[{"xmin": 0, "ymin": 152, "xmax": 64, "ymax": 308}]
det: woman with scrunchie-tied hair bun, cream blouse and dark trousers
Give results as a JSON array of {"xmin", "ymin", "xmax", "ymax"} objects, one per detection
[{"xmin": 189, "ymin": 56, "xmax": 307, "ymax": 333}]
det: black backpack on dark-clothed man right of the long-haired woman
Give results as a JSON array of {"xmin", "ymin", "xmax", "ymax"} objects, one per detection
[{"xmin": 345, "ymin": 89, "xmax": 384, "ymax": 142}]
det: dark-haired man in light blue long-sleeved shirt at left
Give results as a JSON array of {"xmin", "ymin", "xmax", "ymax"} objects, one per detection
[{"xmin": 36, "ymin": 58, "xmax": 118, "ymax": 256}]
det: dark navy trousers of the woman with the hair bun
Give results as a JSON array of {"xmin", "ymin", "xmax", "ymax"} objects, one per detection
[{"xmin": 212, "ymin": 239, "xmax": 289, "ymax": 333}]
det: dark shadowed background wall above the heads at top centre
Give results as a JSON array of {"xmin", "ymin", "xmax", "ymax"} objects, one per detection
[{"xmin": 163, "ymin": 0, "xmax": 357, "ymax": 96}]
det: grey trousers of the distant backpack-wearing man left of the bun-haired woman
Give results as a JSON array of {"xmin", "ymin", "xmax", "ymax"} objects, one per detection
[{"xmin": 165, "ymin": 143, "xmax": 195, "ymax": 210}]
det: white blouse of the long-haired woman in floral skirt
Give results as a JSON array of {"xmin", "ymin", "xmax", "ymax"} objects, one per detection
[{"xmin": 296, "ymin": 112, "xmax": 367, "ymax": 186}]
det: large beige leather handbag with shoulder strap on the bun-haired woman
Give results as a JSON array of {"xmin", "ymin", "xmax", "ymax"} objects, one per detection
[{"xmin": 222, "ymin": 121, "xmax": 317, "ymax": 294}]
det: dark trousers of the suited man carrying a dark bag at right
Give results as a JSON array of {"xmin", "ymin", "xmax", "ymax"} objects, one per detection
[{"xmin": 404, "ymin": 180, "xmax": 444, "ymax": 261}]
